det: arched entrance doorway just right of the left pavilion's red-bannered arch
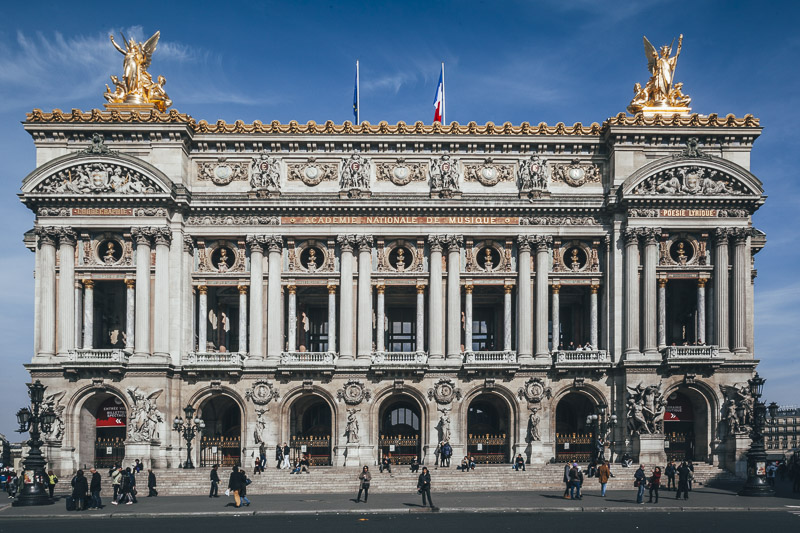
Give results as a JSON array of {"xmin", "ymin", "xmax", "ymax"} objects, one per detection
[{"xmin": 197, "ymin": 394, "xmax": 242, "ymax": 467}]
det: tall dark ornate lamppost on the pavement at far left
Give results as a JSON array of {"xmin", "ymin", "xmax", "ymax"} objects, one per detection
[{"xmin": 12, "ymin": 379, "xmax": 56, "ymax": 507}]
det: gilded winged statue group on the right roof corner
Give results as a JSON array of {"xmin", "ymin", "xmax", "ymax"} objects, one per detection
[{"xmin": 628, "ymin": 34, "xmax": 692, "ymax": 115}]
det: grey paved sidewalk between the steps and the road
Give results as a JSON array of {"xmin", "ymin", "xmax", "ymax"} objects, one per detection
[{"xmin": 0, "ymin": 482, "xmax": 800, "ymax": 520}]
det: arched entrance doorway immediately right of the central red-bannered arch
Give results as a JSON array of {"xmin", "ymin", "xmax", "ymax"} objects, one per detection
[{"xmin": 467, "ymin": 394, "xmax": 511, "ymax": 464}]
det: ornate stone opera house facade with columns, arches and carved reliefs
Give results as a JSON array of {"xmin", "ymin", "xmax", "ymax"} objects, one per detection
[{"xmin": 21, "ymin": 110, "xmax": 765, "ymax": 473}]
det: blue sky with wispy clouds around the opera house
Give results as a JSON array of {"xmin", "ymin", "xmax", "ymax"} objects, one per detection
[{"xmin": 0, "ymin": 0, "xmax": 800, "ymax": 440}]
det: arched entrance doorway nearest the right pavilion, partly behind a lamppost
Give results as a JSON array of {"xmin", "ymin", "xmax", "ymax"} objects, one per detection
[{"xmin": 556, "ymin": 392, "xmax": 594, "ymax": 463}]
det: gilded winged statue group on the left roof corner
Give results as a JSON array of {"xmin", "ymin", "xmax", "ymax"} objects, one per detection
[{"xmin": 103, "ymin": 31, "xmax": 172, "ymax": 113}]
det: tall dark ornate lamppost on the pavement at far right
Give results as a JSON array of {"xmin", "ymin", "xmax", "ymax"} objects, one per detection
[{"xmin": 739, "ymin": 372, "xmax": 778, "ymax": 496}]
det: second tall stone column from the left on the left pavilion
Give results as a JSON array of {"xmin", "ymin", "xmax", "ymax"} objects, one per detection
[{"xmin": 56, "ymin": 227, "xmax": 77, "ymax": 356}]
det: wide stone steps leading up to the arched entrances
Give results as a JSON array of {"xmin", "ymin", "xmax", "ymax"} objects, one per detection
[{"xmin": 102, "ymin": 464, "xmax": 737, "ymax": 497}]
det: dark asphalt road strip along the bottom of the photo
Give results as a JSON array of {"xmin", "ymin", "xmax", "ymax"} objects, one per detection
[{"xmin": 0, "ymin": 508, "xmax": 800, "ymax": 533}]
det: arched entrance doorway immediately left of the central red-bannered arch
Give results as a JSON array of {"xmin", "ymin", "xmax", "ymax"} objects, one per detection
[{"xmin": 289, "ymin": 394, "xmax": 333, "ymax": 466}]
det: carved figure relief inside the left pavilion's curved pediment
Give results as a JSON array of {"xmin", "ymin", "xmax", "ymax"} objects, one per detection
[{"xmin": 33, "ymin": 162, "xmax": 159, "ymax": 194}]
